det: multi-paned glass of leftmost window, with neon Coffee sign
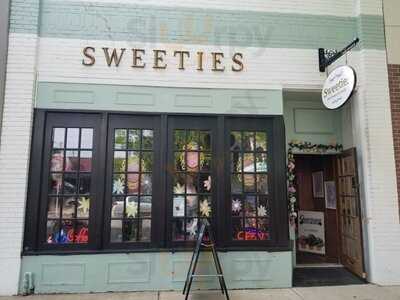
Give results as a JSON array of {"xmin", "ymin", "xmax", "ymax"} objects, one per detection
[{"xmin": 46, "ymin": 128, "xmax": 93, "ymax": 244}]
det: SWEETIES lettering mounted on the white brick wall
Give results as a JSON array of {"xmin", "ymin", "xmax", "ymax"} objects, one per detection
[{"xmin": 82, "ymin": 47, "xmax": 244, "ymax": 72}]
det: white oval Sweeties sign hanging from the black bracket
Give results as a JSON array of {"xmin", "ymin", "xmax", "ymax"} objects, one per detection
[{"xmin": 322, "ymin": 66, "xmax": 357, "ymax": 109}]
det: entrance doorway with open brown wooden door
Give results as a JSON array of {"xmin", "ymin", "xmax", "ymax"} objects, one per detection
[{"xmin": 294, "ymin": 149, "xmax": 365, "ymax": 286}]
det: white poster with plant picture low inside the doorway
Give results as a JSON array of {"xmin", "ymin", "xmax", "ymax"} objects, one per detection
[{"xmin": 298, "ymin": 210, "xmax": 325, "ymax": 255}]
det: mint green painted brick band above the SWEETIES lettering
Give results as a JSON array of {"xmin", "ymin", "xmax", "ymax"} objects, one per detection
[{"xmin": 10, "ymin": 0, "xmax": 385, "ymax": 50}]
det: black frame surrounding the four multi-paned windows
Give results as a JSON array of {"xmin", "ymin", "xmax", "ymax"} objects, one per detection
[{"xmin": 23, "ymin": 109, "xmax": 291, "ymax": 255}]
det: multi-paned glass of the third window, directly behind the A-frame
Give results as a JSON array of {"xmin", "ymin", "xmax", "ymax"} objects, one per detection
[{"xmin": 172, "ymin": 130, "xmax": 212, "ymax": 241}]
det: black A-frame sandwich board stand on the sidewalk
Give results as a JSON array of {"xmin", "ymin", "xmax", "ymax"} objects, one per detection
[{"xmin": 182, "ymin": 219, "xmax": 229, "ymax": 300}]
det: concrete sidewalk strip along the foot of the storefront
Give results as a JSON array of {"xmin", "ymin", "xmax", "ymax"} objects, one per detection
[{"xmin": 0, "ymin": 284, "xmax": 400, "ymax": 300}]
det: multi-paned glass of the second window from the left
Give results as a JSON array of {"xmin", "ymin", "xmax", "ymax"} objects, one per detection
[{"xmin": 110, "ymin": 129, "xmax": 154, "ymax": 243}]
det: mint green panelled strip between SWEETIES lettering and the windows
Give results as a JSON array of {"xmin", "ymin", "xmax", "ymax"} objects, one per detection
[{"xmin": 36, "ymin": 82, "xmax": 283, "ymax": 115}]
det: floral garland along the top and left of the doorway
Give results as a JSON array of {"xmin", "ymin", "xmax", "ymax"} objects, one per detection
[{"xmin": 287, "ymin": 140, "xmax": 343, "ymax": 225}]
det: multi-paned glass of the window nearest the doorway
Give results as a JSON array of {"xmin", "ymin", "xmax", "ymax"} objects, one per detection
[{"xmin": 230, "ymin": 131, "xmax": 270, "ymax": 240}]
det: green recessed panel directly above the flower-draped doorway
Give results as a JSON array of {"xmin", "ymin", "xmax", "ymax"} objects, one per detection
[{"xmin": 284, "ymin": 98, "xmax": 342, "ymax": 144}]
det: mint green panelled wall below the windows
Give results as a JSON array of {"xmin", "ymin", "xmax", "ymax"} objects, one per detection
[{"xmin": 19, "ymin": 252, "xmax": 292, "ymax": 293}]
